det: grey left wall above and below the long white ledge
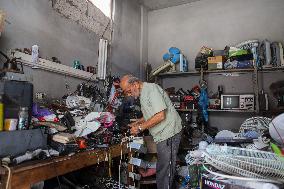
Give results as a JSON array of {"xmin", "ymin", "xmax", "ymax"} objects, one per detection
[{"xmin": 0, "ymin": 0, "xmax": 99, "ymax": 98}]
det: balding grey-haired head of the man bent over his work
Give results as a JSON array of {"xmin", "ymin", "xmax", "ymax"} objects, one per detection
[{"xmin": 120, "ymin": 75, "xmax": 142, "ymax": 98}]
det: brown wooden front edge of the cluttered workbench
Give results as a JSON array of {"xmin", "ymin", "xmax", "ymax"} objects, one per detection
[{"xmin": 0, "ymin": 144, "xmax": 128, "ymax": 189}]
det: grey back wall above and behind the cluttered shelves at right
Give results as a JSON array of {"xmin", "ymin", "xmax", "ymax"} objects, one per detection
[{"xmin": 148, "ymin": 0, "xmax": 284, "ymax": 129}]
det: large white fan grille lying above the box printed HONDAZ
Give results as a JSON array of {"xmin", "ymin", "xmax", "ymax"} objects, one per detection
[{"xmin": 204, "ymin": 144, "xmax": 284, "ymax": 182}]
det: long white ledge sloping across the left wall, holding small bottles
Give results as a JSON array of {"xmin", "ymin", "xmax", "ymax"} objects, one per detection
[{"xmin": 11, "ymin": 51, "xmax": 96, "ymax": 81}]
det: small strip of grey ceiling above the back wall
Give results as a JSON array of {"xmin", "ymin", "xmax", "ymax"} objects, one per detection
[{"xmin": 140, "ymin": 0, "xmax": 199, "ymax": 10}]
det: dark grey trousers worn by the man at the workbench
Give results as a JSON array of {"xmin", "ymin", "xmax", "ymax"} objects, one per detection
[{"xmin": 156, "ymin": 132, "xmax": 181, "ymax": 189}]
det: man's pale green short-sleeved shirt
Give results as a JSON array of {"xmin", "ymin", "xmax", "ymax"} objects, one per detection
[{"xmin": 140, "ymin": 82, "xmax": 182, "ymax": 143}]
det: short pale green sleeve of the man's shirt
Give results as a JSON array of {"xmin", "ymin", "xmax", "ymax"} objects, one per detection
[{"xmin": 148, "ymin": 86, "xmax": 167, "ymax": 117}]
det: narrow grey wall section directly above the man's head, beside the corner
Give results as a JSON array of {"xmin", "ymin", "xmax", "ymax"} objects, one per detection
[{"xmin": 111, "ymin": 0, "xmax": 141, "ymax": 76}]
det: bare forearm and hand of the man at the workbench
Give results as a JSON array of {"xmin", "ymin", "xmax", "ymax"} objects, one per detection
[{"xmin": 131, "ymin": 110, "xmax": 166, "ymax": 135}]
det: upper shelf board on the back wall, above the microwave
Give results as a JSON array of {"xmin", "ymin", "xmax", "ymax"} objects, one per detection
[{"xmin": 158, "ymin": 67, "xmax": 284, "ymax": 77}]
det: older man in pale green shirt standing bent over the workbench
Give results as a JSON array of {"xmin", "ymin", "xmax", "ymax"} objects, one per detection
[{"xmin": 120, "ymin": 75, "xmax": 182, "ymax": 189}]
